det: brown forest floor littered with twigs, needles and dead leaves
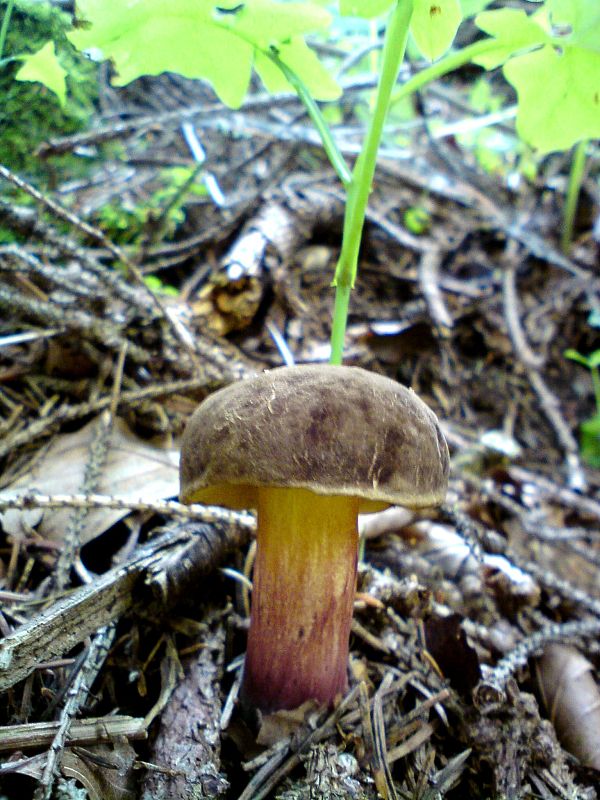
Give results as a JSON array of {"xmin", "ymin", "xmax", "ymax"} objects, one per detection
[{"xmin": 0, "ymin": 53, "xmax": 600, "ymax": 800}]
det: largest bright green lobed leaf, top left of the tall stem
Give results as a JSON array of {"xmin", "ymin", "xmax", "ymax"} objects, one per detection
[{"xmin": 69, "ymin": 0, "xmax": 339, "ymax": 108}]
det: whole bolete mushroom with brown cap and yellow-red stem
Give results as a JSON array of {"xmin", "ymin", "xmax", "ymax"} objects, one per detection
[{"xmin": 180, "ymin": 365, "xmax": 448, "ymax": 712}]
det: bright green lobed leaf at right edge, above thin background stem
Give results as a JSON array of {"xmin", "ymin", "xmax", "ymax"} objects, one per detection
[{"xmin": 504, "ymin": 47, "xmax": 600, "ymax": 153}]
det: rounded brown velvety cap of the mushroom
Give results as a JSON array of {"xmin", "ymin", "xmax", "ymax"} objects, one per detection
[{"xmin": 180, "ymin": 365, "xmax": 449, "ymax": 510}]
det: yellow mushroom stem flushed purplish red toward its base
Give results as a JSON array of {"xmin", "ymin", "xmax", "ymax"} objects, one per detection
[{"xmin": 242, "ymin": 488, "xmax": 358, "ymax": 712}]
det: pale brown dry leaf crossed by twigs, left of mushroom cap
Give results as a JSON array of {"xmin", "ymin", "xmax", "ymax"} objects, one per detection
[{"xmin": 0, "ymin": 419, "xmax": 179, "ymax": 544}]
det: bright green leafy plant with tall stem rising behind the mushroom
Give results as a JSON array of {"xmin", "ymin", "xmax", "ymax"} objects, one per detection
[{"xmin": 6, "ymin": 0, "xmax": 600, "ymax": 356}]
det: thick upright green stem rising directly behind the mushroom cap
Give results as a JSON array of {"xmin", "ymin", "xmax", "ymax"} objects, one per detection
[{"xmin": 330, "ymin": 0, "xmax": 413, "ymax": 364}]
